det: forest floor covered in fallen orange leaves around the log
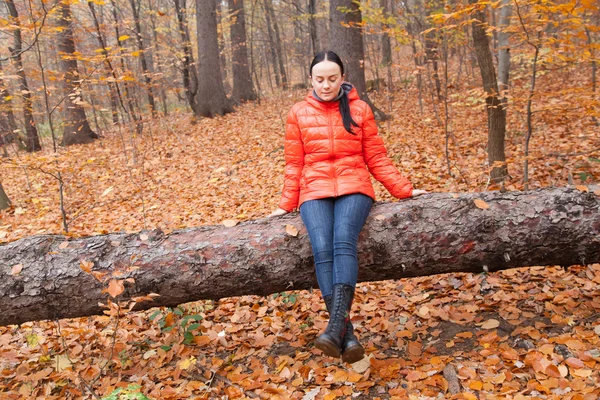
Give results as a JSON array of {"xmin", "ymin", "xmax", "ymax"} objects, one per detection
[{"xmin": 0, "ymin": 76, "xmax": 600, "ymax": 400}]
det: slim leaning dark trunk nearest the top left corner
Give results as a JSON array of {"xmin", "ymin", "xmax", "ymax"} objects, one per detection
[{"xmin": 4, "ymin": 0, "xmax": 42, "ymax": 152}]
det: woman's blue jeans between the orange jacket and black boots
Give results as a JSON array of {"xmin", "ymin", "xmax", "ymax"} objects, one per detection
[{"xmin": 300, "ymin": 193, "xmax": 373, "ymax": 296}]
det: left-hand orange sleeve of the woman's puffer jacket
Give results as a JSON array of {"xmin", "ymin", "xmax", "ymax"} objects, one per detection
[{"xmin": 279, "ymin": 108, "xmax": 304, "ymax": 212}]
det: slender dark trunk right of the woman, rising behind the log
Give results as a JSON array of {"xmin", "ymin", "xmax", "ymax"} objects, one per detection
[{"xmin": 470, "ymin": 0, "xmax": 508, "ymax": 183}]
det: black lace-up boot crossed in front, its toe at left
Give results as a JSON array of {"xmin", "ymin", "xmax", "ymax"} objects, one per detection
[{"xmin": 315, "ymin": 283, "xmax": 354, "ymax": 357}]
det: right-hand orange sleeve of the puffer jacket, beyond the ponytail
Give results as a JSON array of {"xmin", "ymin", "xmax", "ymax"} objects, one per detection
[{"xmin": 362, "ymin": 103, "xmax": 413, "ymax": 199}]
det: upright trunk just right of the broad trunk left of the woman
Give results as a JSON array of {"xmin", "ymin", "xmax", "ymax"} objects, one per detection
[{"xmin": 229, "ymin": 0, "xmax": 256, "ymax": 103}]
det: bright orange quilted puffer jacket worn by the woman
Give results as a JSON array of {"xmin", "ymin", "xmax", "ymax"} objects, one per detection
[{"xmin": 279, "ymin": 88, "xmax": 413, "ymax": 211}]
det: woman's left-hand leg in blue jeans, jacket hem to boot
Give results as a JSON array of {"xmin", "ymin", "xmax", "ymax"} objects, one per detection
[{"xmin": 300, "ymin": 198, "xmax": 334, "ymax": 297}]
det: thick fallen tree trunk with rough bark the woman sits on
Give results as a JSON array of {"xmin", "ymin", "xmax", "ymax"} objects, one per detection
[{"xmin": 0, "ymin": 188, "xmax": 600, "ymax": 325}]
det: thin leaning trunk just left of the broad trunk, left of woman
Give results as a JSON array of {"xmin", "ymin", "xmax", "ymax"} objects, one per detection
[{"xmin": 173, "ymin": 0, "xmax": 199, "ymax": 115}]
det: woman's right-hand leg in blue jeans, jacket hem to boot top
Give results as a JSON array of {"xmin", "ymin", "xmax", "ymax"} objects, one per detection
[{"xmin": 333, "ymin": 193, "xmax": 373, "ymax": 287}]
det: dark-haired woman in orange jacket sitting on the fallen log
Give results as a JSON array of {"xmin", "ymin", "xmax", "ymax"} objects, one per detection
[{"xmin": 269, "ymin": 51, "xmax": 426, "ymax": 363}]
